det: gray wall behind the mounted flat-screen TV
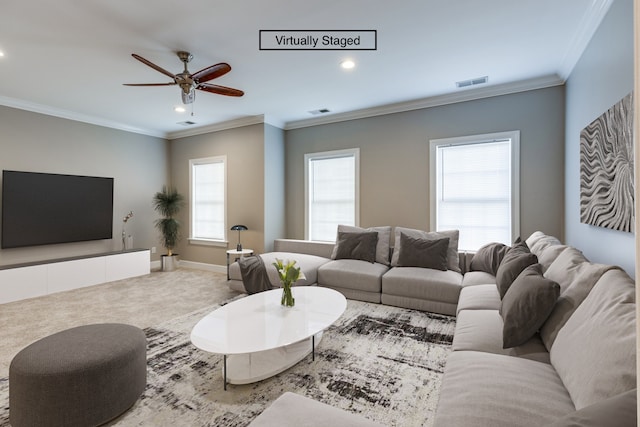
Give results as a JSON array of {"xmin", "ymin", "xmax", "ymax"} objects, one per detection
[{"xmin": 0, "ymin": 106, "xmax": 169, "ymax": 265}]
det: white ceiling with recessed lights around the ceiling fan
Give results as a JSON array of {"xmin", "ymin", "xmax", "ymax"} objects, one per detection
[{"xmin": 0, "ymin": 0, "xmax": 613, "ymax": 138}]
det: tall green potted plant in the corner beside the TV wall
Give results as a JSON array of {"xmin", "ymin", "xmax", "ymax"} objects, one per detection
[{"xmin": 153, "ymin": 185, "xmax": 184, "ymax": 271}]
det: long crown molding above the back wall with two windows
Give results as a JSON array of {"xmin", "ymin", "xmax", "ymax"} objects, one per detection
[{"xmin": 283, "ymin": 74, "xmax": 565, "ymax": 130}]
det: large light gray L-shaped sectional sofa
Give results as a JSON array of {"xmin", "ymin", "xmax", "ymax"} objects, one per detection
[{"xmin": 232, "ymin": 229, "xmax": 637, "ymax": 427}]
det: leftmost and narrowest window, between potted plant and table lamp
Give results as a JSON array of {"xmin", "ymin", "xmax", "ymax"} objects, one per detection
[{"xmin": 189, "ymin": 156, "xmax": 227, "ymax": 244}]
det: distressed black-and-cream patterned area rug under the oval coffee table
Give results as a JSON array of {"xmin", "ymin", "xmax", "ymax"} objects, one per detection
[{"xmin": 0, "ymin": 300, "xmax": 455, "ymax": 427}]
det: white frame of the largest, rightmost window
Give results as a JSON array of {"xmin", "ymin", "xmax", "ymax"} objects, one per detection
[{"xmin": 429, "ymin": 130, "xmax": 520, "ymax": 249}]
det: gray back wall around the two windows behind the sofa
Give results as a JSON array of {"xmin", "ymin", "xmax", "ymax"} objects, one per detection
[{"xmin": 286, "ymin": 86, "xmax": 564, "ymax": 244}]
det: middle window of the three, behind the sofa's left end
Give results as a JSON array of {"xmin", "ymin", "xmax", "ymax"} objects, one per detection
[{"xmin": 304, "ymin": 148, "xmax": 360, "ymax": 242}]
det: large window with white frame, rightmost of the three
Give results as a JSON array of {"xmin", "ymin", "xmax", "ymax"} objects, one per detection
[{"xmin": 430, "ymin": 131, "xmax": 520, "ymax": 250}]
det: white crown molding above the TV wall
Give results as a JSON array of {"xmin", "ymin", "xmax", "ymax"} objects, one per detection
[{"xmin": 0, "ymin": 96, "xmax": 166, "ymax": 138}]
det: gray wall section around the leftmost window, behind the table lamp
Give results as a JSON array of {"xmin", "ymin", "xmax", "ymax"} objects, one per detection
[{"xmin": 170, "ymin": 124, "xmax": 265, "ymax": 265}]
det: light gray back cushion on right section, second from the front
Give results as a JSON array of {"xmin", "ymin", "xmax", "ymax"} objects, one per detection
[{"xmin": 540, "ymin": 262, "xmax": 617, "ymax": 349}]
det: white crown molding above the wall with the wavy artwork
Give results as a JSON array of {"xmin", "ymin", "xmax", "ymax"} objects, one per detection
[{"xmin": 559, "ymin": 0, "xmax": 614, "ymax": 80}]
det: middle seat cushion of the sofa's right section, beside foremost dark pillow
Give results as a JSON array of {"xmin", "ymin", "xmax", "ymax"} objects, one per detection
[{"xmin": 452, "ymin": 310, "xmax": 550, "ymax": 363}]
